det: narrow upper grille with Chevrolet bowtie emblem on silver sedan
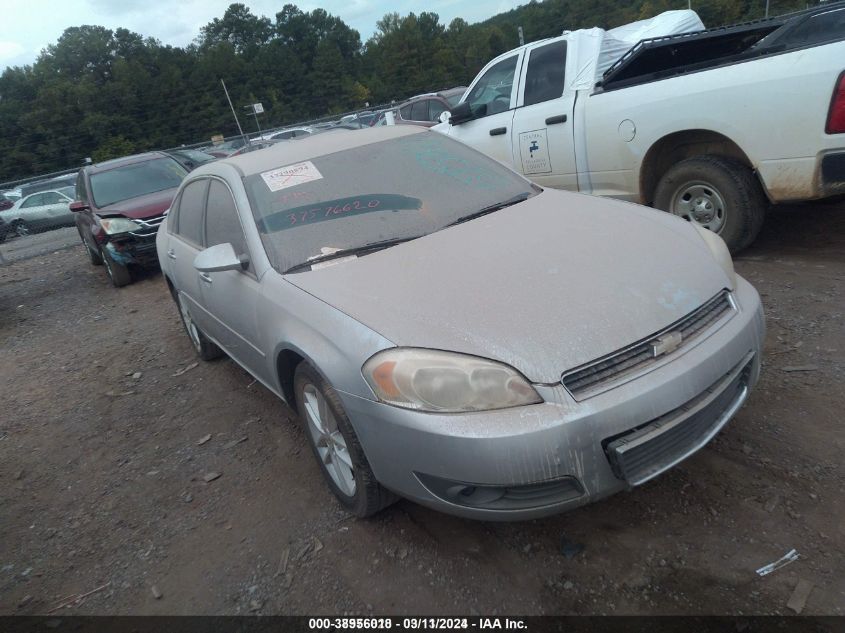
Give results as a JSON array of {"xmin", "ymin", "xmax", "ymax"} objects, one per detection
[{"xmin": 562, "ymin": 290, "xmax": 734, "ymax": 399}]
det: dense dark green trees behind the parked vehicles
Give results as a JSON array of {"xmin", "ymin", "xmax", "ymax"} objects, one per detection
[{"xmin": 0, "ymin": 0, "xmax": 806, "ymax": 182}]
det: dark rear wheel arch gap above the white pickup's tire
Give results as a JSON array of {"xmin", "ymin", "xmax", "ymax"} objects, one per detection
[{"xmin": 639, "ymin": 129, "xmax": 766, "ymax": 205}]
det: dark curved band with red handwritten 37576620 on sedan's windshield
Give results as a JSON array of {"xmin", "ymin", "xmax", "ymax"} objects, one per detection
[{"xmin": 254, "ymin": 193, "xmax": 422, "ymax": 233}]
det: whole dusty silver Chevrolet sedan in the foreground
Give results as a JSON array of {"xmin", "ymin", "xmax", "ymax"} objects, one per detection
[{"xmin": 157, "ymin": 126, "xmax": 764, "ymax": 520}]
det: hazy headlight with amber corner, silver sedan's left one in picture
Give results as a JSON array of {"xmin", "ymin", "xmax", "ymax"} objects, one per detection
[{"xmin": 362, "ymin": 348, "xmax": 543, "ymax": 413}]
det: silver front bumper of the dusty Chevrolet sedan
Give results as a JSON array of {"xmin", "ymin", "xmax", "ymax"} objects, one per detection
[{"xmin": 339, "ymin": 278, "xmax": 765, "ymax": 520}]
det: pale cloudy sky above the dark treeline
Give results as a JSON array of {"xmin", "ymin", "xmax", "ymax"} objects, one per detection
[{"xmin": 0, "ymin": 0, "xmax": 527, "ymax": 70}]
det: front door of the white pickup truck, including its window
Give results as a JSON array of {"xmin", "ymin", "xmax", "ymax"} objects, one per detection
[{"xmin": 438, "ymin": 50, "xmax": 523, "ymax": 170}]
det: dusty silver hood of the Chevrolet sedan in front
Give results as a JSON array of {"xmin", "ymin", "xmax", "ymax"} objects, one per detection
[{"xmin": 286, "ymin": 190, "xmax": 729, "ymax": 383}]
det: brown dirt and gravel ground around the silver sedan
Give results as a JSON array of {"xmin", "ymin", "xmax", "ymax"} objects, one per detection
[{"xmin": 0, "ymin": 204, "xmax": 845, "ymax": 615}]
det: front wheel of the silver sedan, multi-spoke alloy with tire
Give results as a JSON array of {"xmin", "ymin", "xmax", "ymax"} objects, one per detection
[{"xmin": 293, "ymin": 362, "xmax": 397, "ymax": 518}]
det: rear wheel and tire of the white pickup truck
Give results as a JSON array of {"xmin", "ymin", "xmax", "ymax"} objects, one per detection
[{"xmin": 654, "ymin": 156, "xmax": 767, "ymax": 253}]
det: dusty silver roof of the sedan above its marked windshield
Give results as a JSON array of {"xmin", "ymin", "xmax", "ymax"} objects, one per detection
[{"xmin": 209, "ymin": 125, "xmax": 429, "ymax": 177}]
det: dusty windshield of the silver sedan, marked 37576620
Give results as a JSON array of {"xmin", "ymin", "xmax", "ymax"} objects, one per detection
[{"xmin": 244, "ymin": 133, "xmax": 539, "ymax": 272}]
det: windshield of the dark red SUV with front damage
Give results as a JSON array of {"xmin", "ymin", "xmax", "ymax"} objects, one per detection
[{"xmin": 91, "ymin": 157, "xmax": 187, "ymax": 207}]
